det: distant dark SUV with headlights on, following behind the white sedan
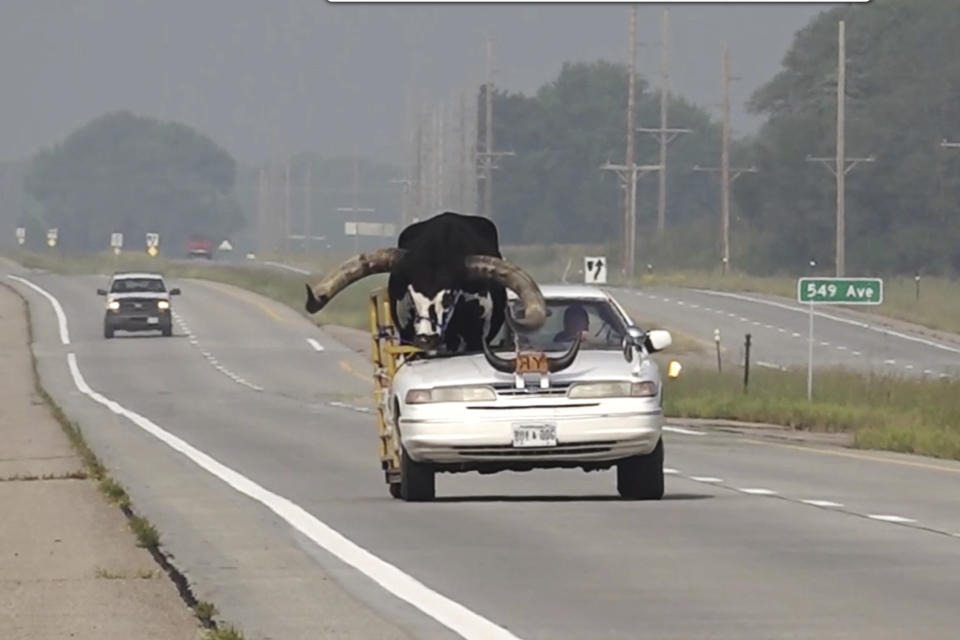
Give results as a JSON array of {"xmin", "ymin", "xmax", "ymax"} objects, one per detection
[{"xmin": 97, "ymin": 272, "xmax": 180, "ymax": 338}]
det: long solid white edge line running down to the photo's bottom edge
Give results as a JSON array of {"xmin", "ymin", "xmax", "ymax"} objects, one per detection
[{"xmin": 67, "ymin": 353, "xmax": 518, "ymax": 640}]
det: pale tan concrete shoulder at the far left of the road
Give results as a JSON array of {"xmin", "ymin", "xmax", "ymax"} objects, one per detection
[{"xmin": 0, "ymin": 287, "xmax": 201, "ymax": 640}]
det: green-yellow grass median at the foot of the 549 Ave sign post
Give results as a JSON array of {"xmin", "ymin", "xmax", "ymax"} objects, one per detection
[{"xmin": 665, "ymin": 369, "xmax": 960, "ymax": 460}]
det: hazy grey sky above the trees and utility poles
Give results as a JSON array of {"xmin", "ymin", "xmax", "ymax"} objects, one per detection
[{"xmin": 0, "ymin": 0, "xmax": 825, "ymax": 163}]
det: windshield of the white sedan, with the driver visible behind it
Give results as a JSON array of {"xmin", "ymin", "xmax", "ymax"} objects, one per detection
[{"xmin": 493, "ymin": 298, "xmax": 626, "ymax": 351}]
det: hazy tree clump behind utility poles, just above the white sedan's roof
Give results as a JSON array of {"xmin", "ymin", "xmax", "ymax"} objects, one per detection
[{"xmin": 488, "ymin": 61, "xmax": 719, "ymax": 259}]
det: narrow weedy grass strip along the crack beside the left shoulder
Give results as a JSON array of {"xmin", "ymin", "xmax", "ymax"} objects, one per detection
[{"xmin": 2, "ymin": 283, "xmax": 244, "ymax": 640}]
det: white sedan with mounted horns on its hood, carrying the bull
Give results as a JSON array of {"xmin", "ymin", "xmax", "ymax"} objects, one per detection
[{"xmin": 384, "ymin": 285, "xmax": 671, "ymax": 501}]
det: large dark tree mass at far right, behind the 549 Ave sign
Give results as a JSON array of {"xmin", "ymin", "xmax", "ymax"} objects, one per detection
[{"xmin": 738, "ymin": 0, "xmax": 960, "ymax": 272}]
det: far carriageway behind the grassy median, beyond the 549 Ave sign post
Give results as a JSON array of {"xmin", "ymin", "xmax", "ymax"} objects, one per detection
[{"xmin": 611, "ymin": 287, "xmax": 960, "ymax": 377}]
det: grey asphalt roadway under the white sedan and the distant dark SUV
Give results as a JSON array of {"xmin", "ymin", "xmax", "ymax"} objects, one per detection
[{"xmin": 0, "ymin": 264, "xmax": 960, "ymax": 640}]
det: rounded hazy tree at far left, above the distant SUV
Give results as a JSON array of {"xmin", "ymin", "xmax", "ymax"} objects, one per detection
[{"xmin": 24, "ymin": 112, "xmax": 243, "ymax": 255}]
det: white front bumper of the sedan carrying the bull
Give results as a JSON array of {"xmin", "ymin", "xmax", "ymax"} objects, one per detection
[{"xmin": 400, "ymin": 406, "xmax": 663, "ymax": 469}]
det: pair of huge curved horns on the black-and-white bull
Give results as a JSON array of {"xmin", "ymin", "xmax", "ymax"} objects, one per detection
[{"xmin": 306, "ymin": 248, "xmax": 579, "ymax": 368}]
